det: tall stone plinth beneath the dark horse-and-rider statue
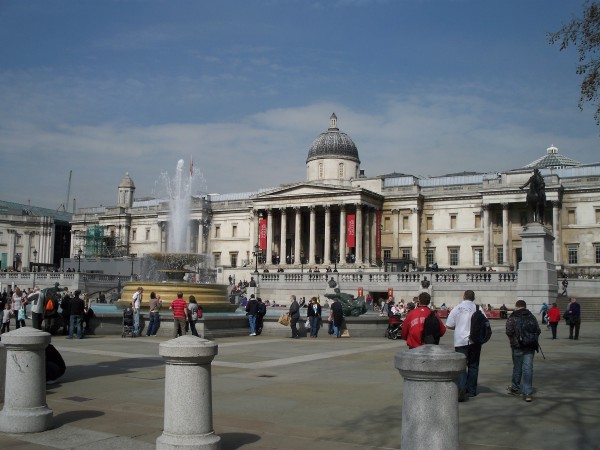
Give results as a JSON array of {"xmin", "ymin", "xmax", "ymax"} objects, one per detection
[{"xmin": 515, "ymin": 223, "xmax": 558, "ymax": 311}]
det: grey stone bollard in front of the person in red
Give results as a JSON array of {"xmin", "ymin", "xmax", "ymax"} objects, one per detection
[{"xmin": 394, "ymin": 345, "xmax": 466, "ymax": 450}]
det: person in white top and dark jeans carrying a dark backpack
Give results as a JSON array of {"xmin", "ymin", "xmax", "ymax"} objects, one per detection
[{"xmin": 446, "ymin": 290, "xmax": 489, "ymax": 402}]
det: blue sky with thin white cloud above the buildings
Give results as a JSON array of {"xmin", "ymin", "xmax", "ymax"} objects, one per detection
[{"xmin": 0, "ymin": 0, "xmax": 600, "ymax": 208}]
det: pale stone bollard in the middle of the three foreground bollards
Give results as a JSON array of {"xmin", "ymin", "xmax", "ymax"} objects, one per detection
[{"xmin": 156, "ymin": 336, "xmax": 221, "ymax": 450}]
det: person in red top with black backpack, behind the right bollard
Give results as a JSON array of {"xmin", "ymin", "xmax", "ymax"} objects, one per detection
[{"xmin": 402, "ymin": 292, "xmax": 446, "ymax": 349}]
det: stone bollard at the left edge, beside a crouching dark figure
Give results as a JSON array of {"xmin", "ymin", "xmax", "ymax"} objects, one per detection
[{"xmin": 0, "ymin": 327, "xmax": 52, "ymax": 433}]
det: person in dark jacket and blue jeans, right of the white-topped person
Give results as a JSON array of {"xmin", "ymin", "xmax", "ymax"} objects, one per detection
[{"xmin": 506, "ymin": 300, "xmax": 542, "ymax": 402}]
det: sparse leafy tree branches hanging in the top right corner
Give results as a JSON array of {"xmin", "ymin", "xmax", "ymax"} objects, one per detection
[{"xmin": 548, "ymin": 0, "xmax": 600, "ymax": 125}]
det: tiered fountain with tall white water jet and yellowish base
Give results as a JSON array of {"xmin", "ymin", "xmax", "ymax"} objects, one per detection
[{"xmin": 119, "ymin": 159, "xmax": 237, "ymax": 312}]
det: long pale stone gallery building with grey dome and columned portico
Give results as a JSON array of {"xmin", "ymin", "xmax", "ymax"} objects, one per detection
[{"xmin": 62, "ymin": 114, "xmax": 600, "ymax": 279}]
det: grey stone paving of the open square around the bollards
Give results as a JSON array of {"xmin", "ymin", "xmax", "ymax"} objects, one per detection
[{"xmin": 0, "ymin": 321, "xmax": 600, "ymax": 450}]
